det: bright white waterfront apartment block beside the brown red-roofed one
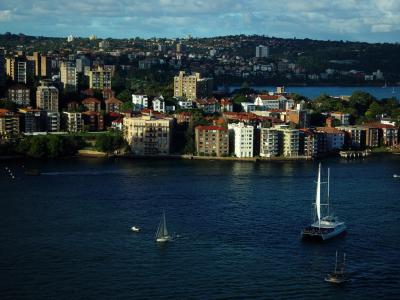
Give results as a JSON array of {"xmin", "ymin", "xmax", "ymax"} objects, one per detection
[{"xmin": 228, "ymin": 123, "xmax": 254, "ymax": 157}]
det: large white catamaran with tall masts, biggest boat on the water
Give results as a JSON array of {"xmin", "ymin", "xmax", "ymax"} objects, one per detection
[{"xmin": 301, "ymin": 164, "xmax": 346, "ymax": 241}]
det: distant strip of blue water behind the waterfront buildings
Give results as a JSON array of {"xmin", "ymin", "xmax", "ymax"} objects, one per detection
[{"xmin": 219, "ymin": 86, "xmax": 400, "ymax": 100}]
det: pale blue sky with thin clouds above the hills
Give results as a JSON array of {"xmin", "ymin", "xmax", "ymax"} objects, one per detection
[{"xmin": 0, "ymin": 0, "xmax": 400, "ymax": 43}]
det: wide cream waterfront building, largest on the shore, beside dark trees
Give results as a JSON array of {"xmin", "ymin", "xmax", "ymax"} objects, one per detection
[{"xmin": 123, "ymin": 115, "xmax": 173, "ymax": 155}]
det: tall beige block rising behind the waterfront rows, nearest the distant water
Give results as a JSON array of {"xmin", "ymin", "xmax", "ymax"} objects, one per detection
[{"xmin": 174, "ymin": 71, "xmax": 213, "ymax": 100}]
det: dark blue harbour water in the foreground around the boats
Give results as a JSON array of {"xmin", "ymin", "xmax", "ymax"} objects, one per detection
[{"xmin": 0, "ymin": 155, "xmax": 400, "ymax": 299}]
